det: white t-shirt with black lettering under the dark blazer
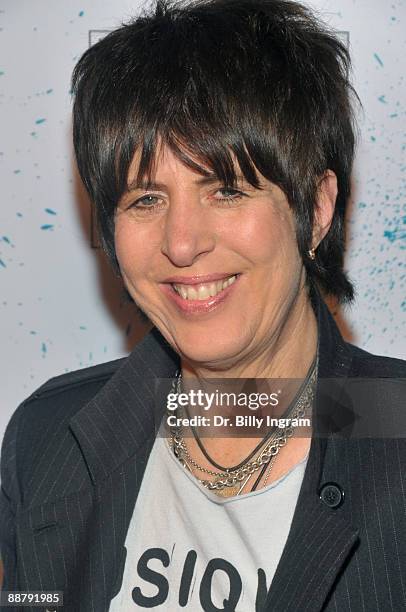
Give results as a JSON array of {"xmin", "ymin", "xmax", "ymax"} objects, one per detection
[{"xmin": 109, "ymin": 437, "xmax": 307, "ymax": 612}]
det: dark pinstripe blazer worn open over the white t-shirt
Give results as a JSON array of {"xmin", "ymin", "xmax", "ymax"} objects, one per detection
[{"xmin": 1, "ymin": 300, "xmax": 406, "ymax": 612}]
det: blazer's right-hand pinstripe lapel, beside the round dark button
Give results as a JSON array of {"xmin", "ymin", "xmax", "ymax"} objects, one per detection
[{"xmin": 265, "ymin": 297, "xmax": 358, "ymax": 612}]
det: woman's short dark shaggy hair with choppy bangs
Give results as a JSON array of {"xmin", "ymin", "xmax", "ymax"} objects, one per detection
[{"xmin": 72, "ymin": 0, "xmax": 356, "ymax": 301}]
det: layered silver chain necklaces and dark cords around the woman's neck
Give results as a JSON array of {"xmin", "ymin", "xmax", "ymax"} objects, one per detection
[{"xmin": 170, "ymin": 357, "xmax": 317, "ymax": 497}]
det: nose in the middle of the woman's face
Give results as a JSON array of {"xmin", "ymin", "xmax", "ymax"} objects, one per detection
[{"xmin": 161, "ymin": 194, "xmax": 216, "ymax": 268}]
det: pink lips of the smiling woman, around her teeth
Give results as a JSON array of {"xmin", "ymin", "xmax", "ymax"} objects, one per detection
[{"xmin": 160, "ymin": 274, "xmax": 241, "ymax": 316}]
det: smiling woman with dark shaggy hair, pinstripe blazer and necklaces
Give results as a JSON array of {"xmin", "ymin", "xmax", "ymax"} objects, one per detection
[{"xmin": 1, "ymin": 0, "xmax": 406, "ymax": 612}]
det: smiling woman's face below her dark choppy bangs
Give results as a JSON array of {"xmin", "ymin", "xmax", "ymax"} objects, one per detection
[{"xmin": 115, "ymin": 148, "xmax": 306, "ymax": 369}]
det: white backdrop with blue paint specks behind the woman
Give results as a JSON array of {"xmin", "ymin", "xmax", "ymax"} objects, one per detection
[{"xmin": 0, "ymin": 0, "xmax": 406, "ymax": 438}]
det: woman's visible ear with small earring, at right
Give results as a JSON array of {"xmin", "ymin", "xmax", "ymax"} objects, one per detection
[{"xmin": 312, "ymin": 170, "xmax": 338, "ymax": 249}]
